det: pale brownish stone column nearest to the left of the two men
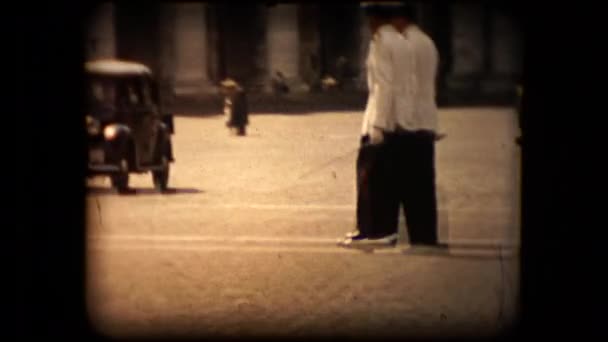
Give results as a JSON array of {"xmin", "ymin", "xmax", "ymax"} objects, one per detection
[{"xmin": 266, "ymin": 4, "xmax": 303, "ymax": 92}]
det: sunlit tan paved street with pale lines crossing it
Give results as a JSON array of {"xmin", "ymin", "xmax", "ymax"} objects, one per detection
[{"xmin": 87, "ymin": 108, "xmax": 520, "ymax": 337}]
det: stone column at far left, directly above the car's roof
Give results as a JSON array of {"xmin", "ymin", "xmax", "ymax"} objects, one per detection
[{"xmin": 85, "ymin": 3, "xmax": 116, "ymax": 60}]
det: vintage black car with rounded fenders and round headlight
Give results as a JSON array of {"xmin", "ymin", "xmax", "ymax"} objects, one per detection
[{"xmin": 85, "ymin": 60, "xmax": 174, "ymax": 193}]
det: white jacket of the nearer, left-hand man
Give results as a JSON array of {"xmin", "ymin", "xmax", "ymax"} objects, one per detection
[{"xmin": 361, "ymin": 25, "xmax": 415, "ymax": 135}]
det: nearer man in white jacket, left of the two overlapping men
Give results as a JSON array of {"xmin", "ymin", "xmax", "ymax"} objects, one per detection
[{"xmin": 340, "ymin": 2, "xmax": 416, "ymax": 246}]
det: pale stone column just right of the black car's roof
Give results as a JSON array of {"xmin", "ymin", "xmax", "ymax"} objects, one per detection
[{"xmin": 174, "ymin": 3, "xmax": 214, "ymax": 95}]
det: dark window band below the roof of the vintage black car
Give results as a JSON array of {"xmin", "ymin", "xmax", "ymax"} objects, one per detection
[{"xmin": 88, "ymin": 77, "xmax": 154, "ymax": 120}]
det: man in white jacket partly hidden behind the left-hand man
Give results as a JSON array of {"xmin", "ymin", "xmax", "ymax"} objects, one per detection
[{"xmin": 384, "ymin": 5, "xmax": 444, "ymax": 247}]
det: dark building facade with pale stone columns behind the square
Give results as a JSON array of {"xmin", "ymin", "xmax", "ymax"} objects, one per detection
[{"xmin": 85, "ymin": 1, "xmax": 523, "ymax": 103}]
